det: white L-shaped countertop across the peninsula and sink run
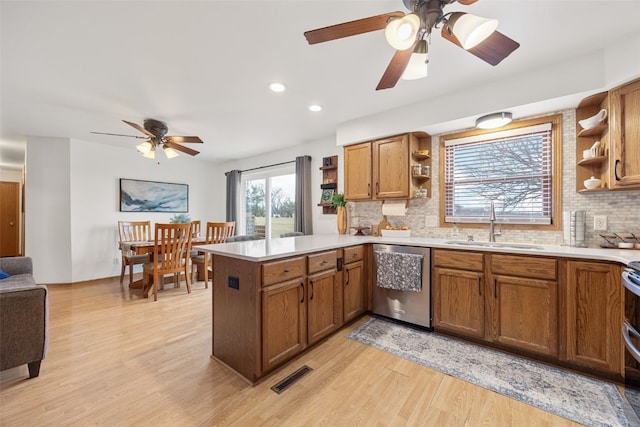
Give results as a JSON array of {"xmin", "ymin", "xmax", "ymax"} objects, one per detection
[{"xmin": 194, "ymin": 234, "xmax": 640, "ymax": 265}]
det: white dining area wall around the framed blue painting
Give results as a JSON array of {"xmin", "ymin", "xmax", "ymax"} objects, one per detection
[{"xmin": 26, "ymin": 138, "xmax": 224, "ymax": 283}]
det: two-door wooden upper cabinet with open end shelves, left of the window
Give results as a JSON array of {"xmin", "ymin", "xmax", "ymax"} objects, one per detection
[{"xmin": 344, "ymin": 132, "xmax": 431, "ymax": 201}]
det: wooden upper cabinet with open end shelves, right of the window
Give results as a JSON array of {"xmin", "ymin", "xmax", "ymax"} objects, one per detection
[{"xmin": 576, "ymin": 79, "xmax": 640, "ymax": 192}]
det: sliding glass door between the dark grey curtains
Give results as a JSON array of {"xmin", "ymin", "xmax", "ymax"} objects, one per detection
[{"xmin": 238, "ymin": 164, "xmax": 296, "ymax": 238}]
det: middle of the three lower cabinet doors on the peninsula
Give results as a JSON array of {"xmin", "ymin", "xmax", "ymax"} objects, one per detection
[{"xmin": 307, "ymin": 269, "xmax": 341, "ymax": 344}]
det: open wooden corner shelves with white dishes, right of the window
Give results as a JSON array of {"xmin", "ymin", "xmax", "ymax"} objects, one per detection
[{"xmin": 576, "ymin": 92, "xmax": 610, "ymax": 193}]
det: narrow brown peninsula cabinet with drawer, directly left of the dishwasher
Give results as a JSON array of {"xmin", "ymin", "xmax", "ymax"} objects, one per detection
[{"xmin": 343, "ymin": 245, "xmax": 366, "ymax": 323}]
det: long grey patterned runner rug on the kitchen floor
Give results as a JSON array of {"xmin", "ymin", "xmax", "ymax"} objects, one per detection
[{"xmin": 349, "ymin": 317, "xmax": 636, "ymax": 426}]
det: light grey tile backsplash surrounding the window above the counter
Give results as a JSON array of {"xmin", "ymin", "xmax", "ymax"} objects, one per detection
[{"xmin": 347, "ymin": 110, "xmax": 640, "ymax": 247}]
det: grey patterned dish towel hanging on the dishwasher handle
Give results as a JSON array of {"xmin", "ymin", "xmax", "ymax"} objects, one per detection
[{"xmin": 375, "ymin": 251, "xmax": 422, "ymax": 292}]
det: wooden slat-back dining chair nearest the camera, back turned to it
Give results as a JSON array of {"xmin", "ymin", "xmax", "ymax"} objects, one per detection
[{"xmin": 142, "ymin": 223, "xmax": 191, "ymax": 301}]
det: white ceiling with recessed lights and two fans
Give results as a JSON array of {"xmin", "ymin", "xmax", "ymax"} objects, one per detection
[{"xmin": 0, "ymin": 0, "xmax": 640, "ymax": 170}]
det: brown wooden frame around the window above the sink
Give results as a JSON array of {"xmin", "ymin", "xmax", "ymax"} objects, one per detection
[{"xmin": 439, "ymin": 114, "xmax": 562, "ymax": 231}]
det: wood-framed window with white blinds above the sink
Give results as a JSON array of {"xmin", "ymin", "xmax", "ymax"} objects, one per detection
[{"xmin": 441, "ymin": 115, "xmax": 561, "ymax": 229}]
